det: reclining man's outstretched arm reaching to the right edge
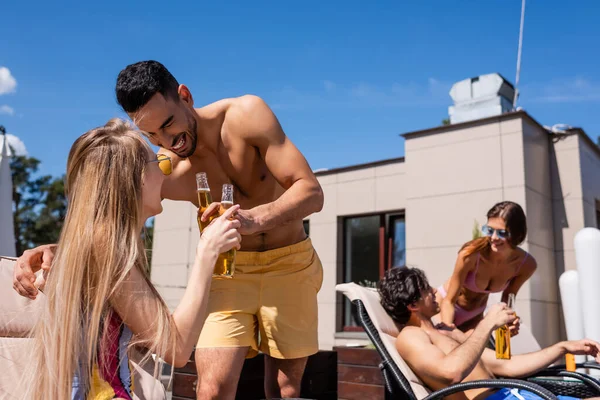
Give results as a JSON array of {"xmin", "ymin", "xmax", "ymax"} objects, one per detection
[{"xmin": 482, "ymin": 339, "xmax": 600, "ymax": 378}]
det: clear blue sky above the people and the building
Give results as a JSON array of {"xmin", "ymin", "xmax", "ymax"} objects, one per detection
[{"xmin": 0, "ymin": 0, "xmax": 600, "ymax": 175}]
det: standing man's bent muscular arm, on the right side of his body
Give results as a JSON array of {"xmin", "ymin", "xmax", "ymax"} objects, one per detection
[{"xmin": 227, "ymin": 96, "xmax": 323, "ymax": 234}]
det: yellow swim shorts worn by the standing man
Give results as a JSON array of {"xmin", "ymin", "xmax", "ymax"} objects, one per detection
[{"xmin": 197, "ymin": 239, "xmax": 323, "ymax": 359}]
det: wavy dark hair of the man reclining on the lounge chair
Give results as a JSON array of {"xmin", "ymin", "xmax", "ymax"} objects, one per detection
[{"xmin": 379, "ymin": 267, "xmax": 430, "ymax": 325}]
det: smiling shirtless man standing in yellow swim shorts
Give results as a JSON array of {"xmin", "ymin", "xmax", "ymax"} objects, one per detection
[{"xmin": 15, "ymin": 61, "xmax": 323, "ymax": 399}]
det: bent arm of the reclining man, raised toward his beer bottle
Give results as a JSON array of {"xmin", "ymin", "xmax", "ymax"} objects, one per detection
[{"xmin": 396, "ymin": 318, "xmax": 497, "ymax": 386}]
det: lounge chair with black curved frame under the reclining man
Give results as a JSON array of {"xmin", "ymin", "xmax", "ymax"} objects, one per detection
[{"xmin": 336, "ymin": 283, "xmax": 600, "ymax": 400}]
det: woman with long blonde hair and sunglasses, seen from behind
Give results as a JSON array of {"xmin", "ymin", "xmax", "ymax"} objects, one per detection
[{"xmin": 14, "ymin": 119, "xmax": 241, "ymax": 400}]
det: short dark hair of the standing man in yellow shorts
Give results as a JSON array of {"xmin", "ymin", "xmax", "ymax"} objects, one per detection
[{"xmin": 115, "ymin": 60, "xmax": 179, "ymax": 113}]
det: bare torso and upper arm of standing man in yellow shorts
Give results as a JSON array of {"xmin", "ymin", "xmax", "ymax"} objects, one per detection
[{"xmin": 141, "ymin": 96, "xmax": 320, "ymax": 251}]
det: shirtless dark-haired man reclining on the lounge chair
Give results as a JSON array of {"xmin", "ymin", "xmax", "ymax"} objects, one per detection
[{"xmin": 379, "ymin": 267, "xmax": 600, "ymax": 400}]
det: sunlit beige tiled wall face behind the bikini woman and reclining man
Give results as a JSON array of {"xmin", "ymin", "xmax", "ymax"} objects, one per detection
[{"xmin": 406, "ymin": 115, "xmax": 524, "ymax": 286}]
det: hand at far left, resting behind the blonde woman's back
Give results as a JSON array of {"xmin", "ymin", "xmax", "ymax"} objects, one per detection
[{"xmin": 13, "ymin": 244, "xmax": 56, "ymax": 300}]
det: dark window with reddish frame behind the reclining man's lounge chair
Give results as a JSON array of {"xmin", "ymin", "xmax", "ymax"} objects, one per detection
[{"xmin": 341, "ymin": 213, "xmax": 406, "ymax": 331}]
